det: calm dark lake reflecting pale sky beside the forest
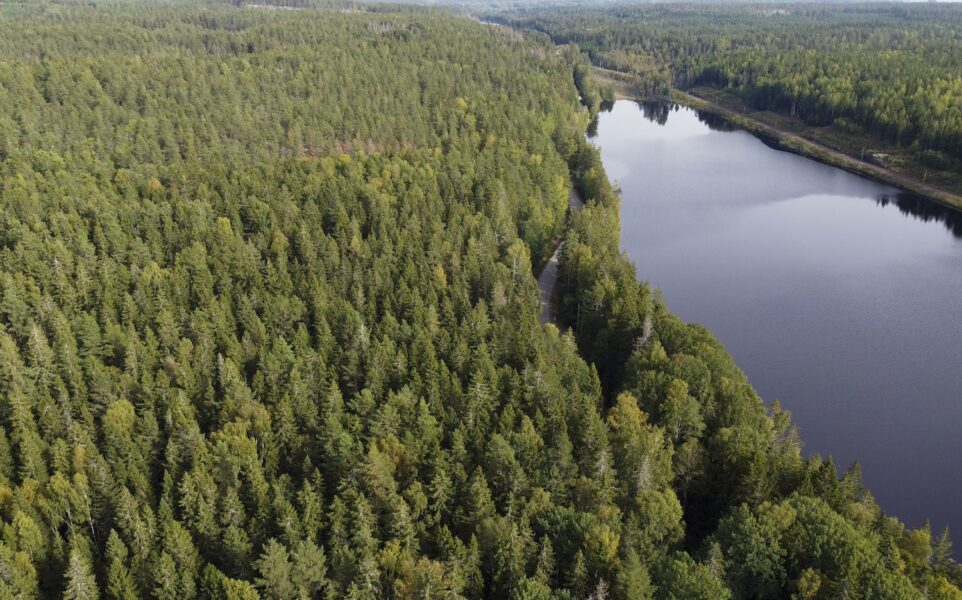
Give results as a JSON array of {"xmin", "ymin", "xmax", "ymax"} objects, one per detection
[{"xmin": 593, "ymin": 101, "xmax": 962, "ymax": 546}]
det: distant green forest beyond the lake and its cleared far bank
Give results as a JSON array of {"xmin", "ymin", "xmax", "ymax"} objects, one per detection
[{"xmin": 499, "ymin": 4, "xmax": 962, "ymax": 169}]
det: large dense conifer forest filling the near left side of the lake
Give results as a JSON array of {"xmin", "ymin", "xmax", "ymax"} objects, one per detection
[{"xmin": 0, "ymin": 3, "xmax": 962, "ymax": 600}]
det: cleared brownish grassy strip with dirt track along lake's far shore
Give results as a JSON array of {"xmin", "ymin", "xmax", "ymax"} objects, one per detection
[{"xmin": 594, "ymin": 67, "xmax": 962, "ymax": 210}]
